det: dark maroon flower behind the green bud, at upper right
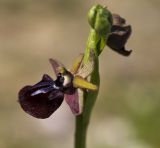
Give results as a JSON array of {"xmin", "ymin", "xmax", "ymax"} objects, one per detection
[{"xmin": 106, "ymin": 14, "xmax": 132, "ymax": 56}]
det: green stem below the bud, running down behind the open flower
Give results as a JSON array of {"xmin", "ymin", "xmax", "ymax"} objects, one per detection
[{"xmin": 75, "ymin": 30, "xmax": 100, "ymax": 148}]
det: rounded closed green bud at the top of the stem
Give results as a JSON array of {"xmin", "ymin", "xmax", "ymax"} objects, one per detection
[{"xmin": 88, "ymin": 5, "xmax": 112, "ymax": 36}]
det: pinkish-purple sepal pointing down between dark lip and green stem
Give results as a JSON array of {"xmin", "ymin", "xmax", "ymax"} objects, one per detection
[{"xmin": 65, "ymin": 90, "xmax": 83, "ymax": 115}]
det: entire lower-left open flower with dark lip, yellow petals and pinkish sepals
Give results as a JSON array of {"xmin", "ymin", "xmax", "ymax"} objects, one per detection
[{"xmin": 19, "ymin": 51, "xmax": 97, "ymax": 119}]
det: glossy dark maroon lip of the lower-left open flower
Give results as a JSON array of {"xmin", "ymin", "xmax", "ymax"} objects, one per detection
[{"xmin": 19, "ymin": 74, "xmax": 64, "ymax": 119}]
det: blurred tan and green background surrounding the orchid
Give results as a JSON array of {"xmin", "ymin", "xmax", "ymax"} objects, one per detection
[{"xmin": 0, "ymin": 0, "xmax": 160, "ymax": 148}]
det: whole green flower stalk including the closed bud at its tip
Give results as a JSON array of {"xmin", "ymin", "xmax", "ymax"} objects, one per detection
[{"xmin": 75, "ymin": 5, "xmax": 111, "ymax": 148}]
